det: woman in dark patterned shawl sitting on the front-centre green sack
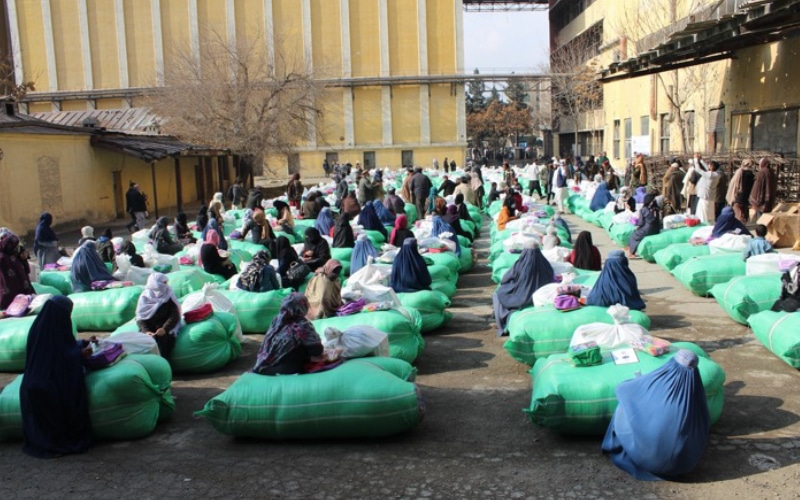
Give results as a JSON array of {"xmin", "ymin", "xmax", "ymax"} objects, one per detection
[{"xmin": 252, "ymin": 292, "xmax": 323, "ymax": 375}]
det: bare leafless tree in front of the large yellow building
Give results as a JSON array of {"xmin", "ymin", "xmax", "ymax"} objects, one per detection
[{"xmin": 154, "ymin": 30, "xmax": 322, "ymax": 175}]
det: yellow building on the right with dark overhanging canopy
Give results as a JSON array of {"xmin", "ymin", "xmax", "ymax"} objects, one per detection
[{"xmin": 550, "ymin": 0, "xmax": 800, "ymax": 165}]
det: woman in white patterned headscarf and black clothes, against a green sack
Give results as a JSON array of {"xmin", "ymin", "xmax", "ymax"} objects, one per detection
[{"xmin": 136, "ymin": 273, "xmax": 181, "ymax": 361}]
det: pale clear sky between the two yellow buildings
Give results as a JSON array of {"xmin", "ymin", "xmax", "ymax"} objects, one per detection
[{"xmin": 464, "ymin": 11, "xmax": 549, "ymax": 73}]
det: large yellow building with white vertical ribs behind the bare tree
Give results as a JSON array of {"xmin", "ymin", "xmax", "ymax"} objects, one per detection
[{"xmin": 0, "ymin": 0, "xmax": 466, "ymax": 173}]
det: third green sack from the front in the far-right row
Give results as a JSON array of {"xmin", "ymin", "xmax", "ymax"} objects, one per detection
[{"xmin": 672, "ymin": 253, "xmax": 745, "ymax": 297}]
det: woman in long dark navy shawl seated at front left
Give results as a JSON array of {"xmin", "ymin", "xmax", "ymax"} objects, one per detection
[{"xmin": 19, "ymin": 294, "xmax": 92, "ymax": 458}]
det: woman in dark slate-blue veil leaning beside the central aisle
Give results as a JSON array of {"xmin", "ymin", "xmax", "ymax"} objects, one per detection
[{"xmin": 492, "ymin": 246, "xmax": 555, "ymax": 336}]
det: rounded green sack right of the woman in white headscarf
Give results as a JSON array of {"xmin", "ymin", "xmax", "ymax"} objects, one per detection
[{"xmin": 110, "ymin": 312, "xmax": 242, "ymax": 373}]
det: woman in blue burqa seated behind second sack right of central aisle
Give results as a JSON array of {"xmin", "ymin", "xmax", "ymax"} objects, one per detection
[{"xmin": 586, "ymin": 250, "xmax": 645, "ymax": 311}]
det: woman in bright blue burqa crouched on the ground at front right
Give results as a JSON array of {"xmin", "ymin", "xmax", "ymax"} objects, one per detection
[{"xmin": 602, "ymin": 349, "xmax": 711, "ymax": 481}]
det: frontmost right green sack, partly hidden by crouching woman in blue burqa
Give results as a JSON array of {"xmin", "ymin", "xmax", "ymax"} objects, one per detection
[{"xmin": 525, "ymin": 342, "xmax": 725, "ymax": 436}]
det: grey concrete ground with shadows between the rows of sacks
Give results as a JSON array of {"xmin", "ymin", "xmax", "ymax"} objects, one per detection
[{"xmin": 0, "ymin": 216, "xmax": 800, "ymax": 499}]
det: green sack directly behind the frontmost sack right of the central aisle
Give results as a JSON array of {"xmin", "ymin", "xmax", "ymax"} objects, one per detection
[{"xmin": 503, "ymin": 306, "xmax": 650, "ymax": 365}]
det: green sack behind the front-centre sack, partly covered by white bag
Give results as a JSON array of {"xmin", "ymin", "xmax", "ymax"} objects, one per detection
[{"xmin": 311, "ymin": 308, "xmax": 425, "ymax": 363}]
